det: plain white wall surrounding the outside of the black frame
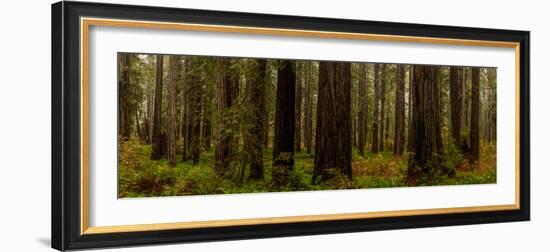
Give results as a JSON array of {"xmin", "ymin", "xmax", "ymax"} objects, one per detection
[{"xmin": 0, "ymin": 0, "xmax": 550, "ymax": 252}]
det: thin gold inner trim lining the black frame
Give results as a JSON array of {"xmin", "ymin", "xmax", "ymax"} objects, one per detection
[{"xmin": 80, "ymin": 18, "xmax": 520, "ymax": 235}]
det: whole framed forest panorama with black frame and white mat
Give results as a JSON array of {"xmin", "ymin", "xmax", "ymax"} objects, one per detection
[{"xmin": 52, "ymin": 1, "xmax": 530, "ymax": 250}]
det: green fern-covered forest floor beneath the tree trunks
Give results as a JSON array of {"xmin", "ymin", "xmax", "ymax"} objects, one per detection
[{"xmin": 118, "ymin": 142, "xmax": 496, "ymax": 198}]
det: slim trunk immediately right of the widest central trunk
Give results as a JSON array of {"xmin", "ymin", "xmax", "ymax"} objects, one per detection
[{"xmin": 357, "ymin": 63, "xmax": 367, "ymax": 156}]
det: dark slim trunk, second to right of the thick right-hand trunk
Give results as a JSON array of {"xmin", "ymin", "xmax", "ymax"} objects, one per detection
[{"xmin": 470, "ymin": 67, "xmax": 479, "ymax": 164}]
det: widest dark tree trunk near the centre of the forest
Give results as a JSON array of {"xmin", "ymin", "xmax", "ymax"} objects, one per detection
[{"xmin": 312, "ymin": 61, "xmax": 352, "ymax": 184}]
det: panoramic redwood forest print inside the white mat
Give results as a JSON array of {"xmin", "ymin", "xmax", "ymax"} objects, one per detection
[{"xmin": 117, "ymin": 53, "xmax": 496, "ymax": 197}]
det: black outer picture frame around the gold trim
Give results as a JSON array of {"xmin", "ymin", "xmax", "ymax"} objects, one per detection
[{"xmin": 51, "ymin": 1, "xmax": 530, "ymax": 251}]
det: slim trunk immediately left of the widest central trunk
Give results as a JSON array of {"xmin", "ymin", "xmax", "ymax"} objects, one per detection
[{"xmin": 304, "ymin": 62, "xmax": 313, "ymax": 154}]
